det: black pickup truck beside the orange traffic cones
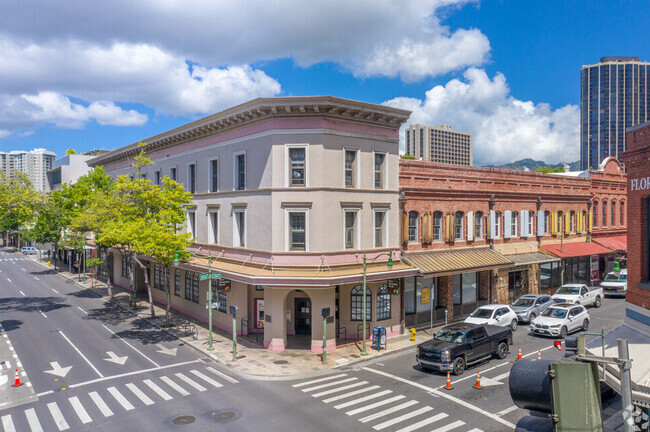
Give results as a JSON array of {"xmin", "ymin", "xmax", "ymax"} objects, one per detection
[{"xmin": 415, "ymin": 323, "xmax": 512, "ymax": 375}]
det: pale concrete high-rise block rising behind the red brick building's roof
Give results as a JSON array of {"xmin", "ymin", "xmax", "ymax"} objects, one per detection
[{"xmin": 405, "ymin": 124, "xmax": 472, "ymax": 166}]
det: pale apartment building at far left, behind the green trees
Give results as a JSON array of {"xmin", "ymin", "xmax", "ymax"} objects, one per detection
[{"xmin": 0, "ymin": 148, "xmax": 56, "ymax": 191}]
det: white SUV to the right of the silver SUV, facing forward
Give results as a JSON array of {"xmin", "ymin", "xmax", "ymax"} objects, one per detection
[{"xmin": 530, "ymin": 303, "xmax": 590, "ymax": 338}]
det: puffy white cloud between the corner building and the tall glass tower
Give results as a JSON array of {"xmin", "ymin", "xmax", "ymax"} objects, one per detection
[{"xmin": 385, "ymin": 68, "xmax": 580, "ymax": 165}]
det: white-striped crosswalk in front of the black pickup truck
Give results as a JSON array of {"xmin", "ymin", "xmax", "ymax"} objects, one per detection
[{"xmin": 292, "ymin": 373, "xmax": 483, "ymax": 432}]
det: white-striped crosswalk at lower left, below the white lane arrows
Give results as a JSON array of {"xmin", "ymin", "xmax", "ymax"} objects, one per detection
[{"xmin": 0, "ymin": 367, "xmax": 238, "ymax": 432}]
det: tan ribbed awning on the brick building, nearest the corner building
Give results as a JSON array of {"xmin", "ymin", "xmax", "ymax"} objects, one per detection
[{"xmin": 403, "ymin": 248, "xmax": 513, "ymax": 276}]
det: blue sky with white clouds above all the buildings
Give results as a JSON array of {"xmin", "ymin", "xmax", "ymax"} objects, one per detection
[{"xmin": 0, "ymin": 0, "xmax": 650, "ymax": 165}]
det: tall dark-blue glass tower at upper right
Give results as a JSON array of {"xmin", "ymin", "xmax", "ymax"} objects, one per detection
[{"xmin": 580, "ymin": 57, "xmax": 650, "ymax": 170}]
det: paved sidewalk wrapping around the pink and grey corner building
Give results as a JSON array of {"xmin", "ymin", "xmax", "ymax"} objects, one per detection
[{"xmin": 35, "ymin": 260, "xmax": 428, "ymax": 380}]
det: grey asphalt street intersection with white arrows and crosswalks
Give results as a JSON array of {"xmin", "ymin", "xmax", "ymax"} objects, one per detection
[{"xmin": 0, "ymin": 249, "xmax": 623, "ymax": 432}]
